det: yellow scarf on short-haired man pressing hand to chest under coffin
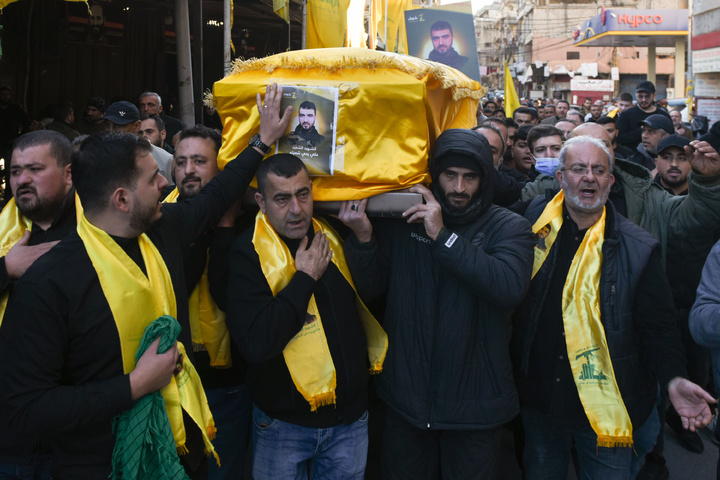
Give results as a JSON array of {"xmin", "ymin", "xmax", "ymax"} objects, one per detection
[{"xmin": 252, "ymin": 212, "xmax": 388, "ymax": 411}]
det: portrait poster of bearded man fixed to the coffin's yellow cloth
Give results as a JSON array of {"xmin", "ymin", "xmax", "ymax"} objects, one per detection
[{"xmin": 276, "ymin": 85, "xmax": 338, "ymax": 175}]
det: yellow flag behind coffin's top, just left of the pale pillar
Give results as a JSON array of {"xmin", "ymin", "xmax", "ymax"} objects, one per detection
[{"xmin": 305, "ymin": 0, "xmax": 350, "ymax": 48}]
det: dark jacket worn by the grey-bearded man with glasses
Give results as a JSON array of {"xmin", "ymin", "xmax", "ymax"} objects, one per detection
[{"xmin": 511, "ymin": 192, "xmax": 687, "ymax": 426}]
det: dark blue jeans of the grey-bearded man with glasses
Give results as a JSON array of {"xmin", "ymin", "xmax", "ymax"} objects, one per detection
[{"xmin": 522, "ymin": 405, "xmax": 657, "ymax": 480}]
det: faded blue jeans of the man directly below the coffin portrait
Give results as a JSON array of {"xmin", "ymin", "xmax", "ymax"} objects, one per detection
[{"xmin": 253, "ymin": 407, "xmax": 368, "ymax": 480}]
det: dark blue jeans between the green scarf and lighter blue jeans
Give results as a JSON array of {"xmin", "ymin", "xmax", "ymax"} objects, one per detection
[{"xmin": 205, "ymin": 384, "xmax": 252, "ymax": 480}]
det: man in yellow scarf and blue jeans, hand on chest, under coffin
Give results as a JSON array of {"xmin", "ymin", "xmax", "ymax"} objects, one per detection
[{"xmin": 227, "ymin": 154, "xmax": 388, "ymax": 480}]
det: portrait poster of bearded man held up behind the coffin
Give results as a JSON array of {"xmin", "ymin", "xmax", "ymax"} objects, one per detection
[{"xmin": 405, "ymin": 6, "xmax": 481, "ymax": 82}]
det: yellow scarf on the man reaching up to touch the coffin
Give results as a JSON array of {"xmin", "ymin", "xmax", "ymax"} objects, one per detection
[{"xmin": 78, "ymin": 215, "xmax": 217, "ymax": 457}]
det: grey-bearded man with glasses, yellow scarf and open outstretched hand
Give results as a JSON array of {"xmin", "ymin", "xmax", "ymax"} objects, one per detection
[{"xmin": 512, "ymin": 136, "xmax": 714, "ymax": 480}]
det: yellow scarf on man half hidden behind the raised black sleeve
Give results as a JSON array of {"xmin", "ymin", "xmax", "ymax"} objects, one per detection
[{"xmin": 163, "ymin": 187, "xmax": 232, "ymax": 368}]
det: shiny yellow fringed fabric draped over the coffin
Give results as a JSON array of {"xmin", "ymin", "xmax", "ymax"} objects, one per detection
[{"xmin": 212, "ymin": 48, "xmax": 485, "ymax": 201}]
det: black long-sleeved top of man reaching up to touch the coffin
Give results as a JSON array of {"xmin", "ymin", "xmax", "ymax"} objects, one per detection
[{"xmin": 0, "ymin": 147, "xmax": 262, "ymax": 479}]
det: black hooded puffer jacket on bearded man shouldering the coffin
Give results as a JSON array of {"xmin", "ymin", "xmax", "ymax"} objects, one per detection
[{"xmin": 345, "ymin": 130, "xmax": 534, "ymax": 429}]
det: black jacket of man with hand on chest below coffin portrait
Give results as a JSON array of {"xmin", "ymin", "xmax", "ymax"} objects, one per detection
[{"xmin": 225, "ymin": 226, "xmax": 369, "ymax": 428}]
